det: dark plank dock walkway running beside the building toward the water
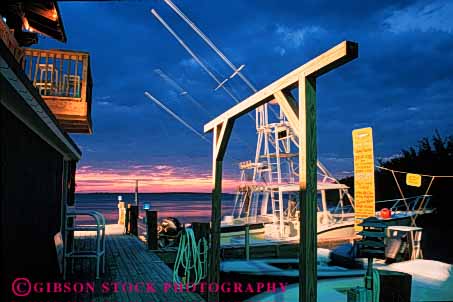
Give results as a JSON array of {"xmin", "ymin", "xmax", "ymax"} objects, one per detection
[{"xmin": 68, "ymin": 224, "xmax": 204, "ymax": 302}]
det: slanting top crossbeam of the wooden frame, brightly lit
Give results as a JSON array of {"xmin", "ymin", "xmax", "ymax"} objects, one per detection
[{"xmin": 204, "ymin": 41, "xmax": 358, "ymax": 133}]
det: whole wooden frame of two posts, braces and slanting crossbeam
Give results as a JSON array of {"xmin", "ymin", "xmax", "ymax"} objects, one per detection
[{"xmin": 204, "ymin": 41, "xmax": 358, "ymax": 301}]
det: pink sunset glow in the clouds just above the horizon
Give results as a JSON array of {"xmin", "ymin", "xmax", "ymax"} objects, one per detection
[{"xmin": 76, "ymin": 165, "xmax": 239, "ymax": 193}]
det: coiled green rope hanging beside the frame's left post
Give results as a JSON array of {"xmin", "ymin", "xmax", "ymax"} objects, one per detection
[{"xmin": 173, "ymin": 228, "xmax": 208, "ymax": 288}]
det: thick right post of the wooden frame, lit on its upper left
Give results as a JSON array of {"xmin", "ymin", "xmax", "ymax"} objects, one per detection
[{"xmin": 299, "ymin": 74, "xmax": 317, "ymax": 302}]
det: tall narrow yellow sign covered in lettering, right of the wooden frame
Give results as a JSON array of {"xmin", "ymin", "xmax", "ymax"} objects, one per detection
[{"xmin": 352, "ymin": 128, "xmax": 376, "ymax": 231}]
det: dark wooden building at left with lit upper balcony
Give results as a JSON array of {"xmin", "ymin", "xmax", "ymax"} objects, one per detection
[{"xmin": 0, "ymin": 0, "xmax": 92, "ymax": 301}]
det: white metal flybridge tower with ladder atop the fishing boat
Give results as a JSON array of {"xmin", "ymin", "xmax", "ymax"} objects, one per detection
[{"xmin": 230, "ymin": 91, "xmax": 353, "ymax": 239}]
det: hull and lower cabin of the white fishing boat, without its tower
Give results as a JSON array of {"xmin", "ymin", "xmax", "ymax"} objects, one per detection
[{"xmin": 221, "ymin": 190, "xmax": 433, "ymax": 244}]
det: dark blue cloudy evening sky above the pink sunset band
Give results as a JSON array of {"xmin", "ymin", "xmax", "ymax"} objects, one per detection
[{"xmin": 38, "ymin": 0, "xmax": 453, "ymax": 188}]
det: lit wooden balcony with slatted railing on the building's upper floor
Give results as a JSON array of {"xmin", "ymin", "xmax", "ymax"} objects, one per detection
[{"xmin": 22, "ymin": 48, "xmax": 93, "ymax": 133}]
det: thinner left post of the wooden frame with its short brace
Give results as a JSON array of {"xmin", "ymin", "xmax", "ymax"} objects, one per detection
[{"xmin": 208, "ymin": 119, "xmax": 233, "ymax": 302}]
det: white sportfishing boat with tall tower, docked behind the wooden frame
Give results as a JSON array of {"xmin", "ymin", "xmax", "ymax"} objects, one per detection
[{"xmin": 221, "ymin": 117, "xmax": 432, "ymax": 244}]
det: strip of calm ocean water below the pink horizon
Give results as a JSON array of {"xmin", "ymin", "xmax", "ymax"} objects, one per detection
[{"xmin": 76, "ymin": 193, "xmax": 234, "ymax": 223}]
